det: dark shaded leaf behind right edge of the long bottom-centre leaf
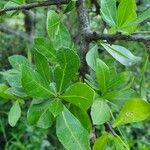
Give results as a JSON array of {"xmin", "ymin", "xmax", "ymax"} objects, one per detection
[{"xmin": 69, "ymin": 105, "xmax": 92, "ymax": 133}]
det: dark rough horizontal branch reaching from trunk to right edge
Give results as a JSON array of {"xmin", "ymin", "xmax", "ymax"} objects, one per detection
[{"xmin": 86, "ymin": 32, "xmax": 150, "ymax": 42}]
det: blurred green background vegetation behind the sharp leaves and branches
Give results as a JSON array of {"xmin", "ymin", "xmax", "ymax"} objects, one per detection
[{"xmin": 0, "ymin": 0, "xmax": 150, "ymax": 150}]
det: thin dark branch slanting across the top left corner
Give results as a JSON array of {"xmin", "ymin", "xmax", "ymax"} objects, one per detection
[{"xmin": 0, "ymin": 0, "xmax": 69, "ymax": 15}]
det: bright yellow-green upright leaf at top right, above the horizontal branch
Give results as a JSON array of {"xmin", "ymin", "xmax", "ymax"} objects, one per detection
[{"xmin": 117, "ymin": 0, "xmax": 137, "ymax": 32}]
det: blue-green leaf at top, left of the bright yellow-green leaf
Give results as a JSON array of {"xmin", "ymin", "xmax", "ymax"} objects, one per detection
[{"xmin": 101, "ymin": 0, "xmax": 117, "ymax": 26}]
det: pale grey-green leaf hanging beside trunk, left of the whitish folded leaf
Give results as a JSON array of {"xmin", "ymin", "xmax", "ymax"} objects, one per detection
[{"xmin": 86, "ymin": 45, "xmax": 99, "ymax": 71}]
